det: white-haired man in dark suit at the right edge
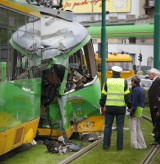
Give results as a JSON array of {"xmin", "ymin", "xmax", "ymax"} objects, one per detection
[{"xmin": 148, "ymin": 68, "xmax": 160, "ymax": 144}]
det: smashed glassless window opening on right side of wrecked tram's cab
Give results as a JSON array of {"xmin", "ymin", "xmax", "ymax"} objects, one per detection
[{"xmin": 65, "ymin": 42, "xmax": 97, "ymax": 92}]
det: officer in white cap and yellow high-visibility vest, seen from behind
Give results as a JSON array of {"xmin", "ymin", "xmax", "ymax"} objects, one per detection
[{"xmin": 99, "ymin": 66, "xmax": 132, "ymax": 150}]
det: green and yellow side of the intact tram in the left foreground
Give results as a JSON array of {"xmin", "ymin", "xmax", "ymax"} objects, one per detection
[{"xmin": 0, "ymin": 1, "xmax": 41, "ymax": 155}]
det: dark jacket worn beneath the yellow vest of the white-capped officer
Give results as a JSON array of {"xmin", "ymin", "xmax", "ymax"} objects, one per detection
[{"xmin": 99, "ymin": 74, "xmax": 132, "ymax": 114}]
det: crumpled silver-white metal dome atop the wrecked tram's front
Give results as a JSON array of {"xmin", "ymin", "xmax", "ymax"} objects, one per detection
[{"xmin": 12, "ymin": 17, "xmax": 88, "ymax": 59}]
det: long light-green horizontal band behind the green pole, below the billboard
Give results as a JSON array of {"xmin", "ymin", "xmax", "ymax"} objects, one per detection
[{"xmin": 87, "ymin": 24, "xmax": 154, "ymax": 38}]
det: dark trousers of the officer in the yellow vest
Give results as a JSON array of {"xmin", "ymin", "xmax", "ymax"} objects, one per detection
[{"xmin": 103, "ymin": 113, "xmax": 125, "ymax": 150}]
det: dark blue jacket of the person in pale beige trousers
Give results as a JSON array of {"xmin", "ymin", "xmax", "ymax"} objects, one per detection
[{"xmin": 130, "ymin": 85, "xmax": 145, "ymax": 116}]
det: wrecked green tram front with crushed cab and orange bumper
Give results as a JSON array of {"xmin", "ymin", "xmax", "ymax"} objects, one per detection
[{"xmin": 33, "ymin": 7, "xmax": 104, "ymax": 138}]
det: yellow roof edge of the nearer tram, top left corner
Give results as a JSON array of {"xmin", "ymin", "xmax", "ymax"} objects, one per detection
[{"xmin": 0, "ymin": 0, "xmax": 41, "ymax": 17}]
